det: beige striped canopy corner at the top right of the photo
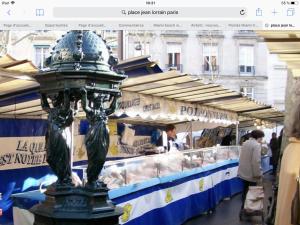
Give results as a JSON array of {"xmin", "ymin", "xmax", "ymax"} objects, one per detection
[{"xmin": 257, "ymin": 31, "xmax": 300, "ymax": 77}]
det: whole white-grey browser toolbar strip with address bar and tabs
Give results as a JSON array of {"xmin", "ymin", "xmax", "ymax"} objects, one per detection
[{"xmin": 1, "ymin": 0, "xmax": 299, "ymax": 30}]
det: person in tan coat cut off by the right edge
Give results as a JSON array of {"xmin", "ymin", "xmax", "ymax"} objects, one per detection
[{"xmin": 275, "ymin": 105, "xmax": 300, "ymax": 225}]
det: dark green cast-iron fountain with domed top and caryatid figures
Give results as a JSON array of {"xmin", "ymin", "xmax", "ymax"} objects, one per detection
[{"xmin": 31, "ymin": 31, "xmax": 126, "ymax": 225}]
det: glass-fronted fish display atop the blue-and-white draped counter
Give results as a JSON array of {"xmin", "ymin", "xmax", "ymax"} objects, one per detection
[{"xmin": 75, "ymin": 146, "xmax": 240, "ymax": 189}]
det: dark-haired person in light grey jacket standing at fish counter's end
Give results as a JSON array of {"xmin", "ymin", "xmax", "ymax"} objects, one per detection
[{"xmin": 238, "ymin": 130, "xmax": 265, "ymax": 209}]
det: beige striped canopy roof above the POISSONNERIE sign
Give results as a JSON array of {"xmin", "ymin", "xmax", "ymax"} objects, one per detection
[{"xmin": 122, "ymin": 71, "xmax": 284, "ymax": 123}]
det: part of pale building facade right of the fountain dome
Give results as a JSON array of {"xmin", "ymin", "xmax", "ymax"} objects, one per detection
[{"xmin": 123, "ymin": 31, "xmax": 287, "ymax": 110}]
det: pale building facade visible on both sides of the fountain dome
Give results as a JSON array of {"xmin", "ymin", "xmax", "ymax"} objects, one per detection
[{"xmin": 0, "ymin": 31, "xmax": 287, "ymax": 110}]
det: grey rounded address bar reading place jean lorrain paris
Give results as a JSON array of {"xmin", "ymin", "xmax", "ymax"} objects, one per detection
[{"xmin": 53, "ymin": 7, "xmax": 247, "ymax": 18}]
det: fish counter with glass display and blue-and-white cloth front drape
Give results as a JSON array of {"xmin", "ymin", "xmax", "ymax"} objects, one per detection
[{"xmin": 76, "ymin": 146, "xmax": 242, "ymax": 225}]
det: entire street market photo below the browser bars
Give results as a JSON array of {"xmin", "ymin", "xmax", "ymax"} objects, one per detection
[{"xmin": 0, "ymin": 30, "xmax": 300, "ymax": 225}]
